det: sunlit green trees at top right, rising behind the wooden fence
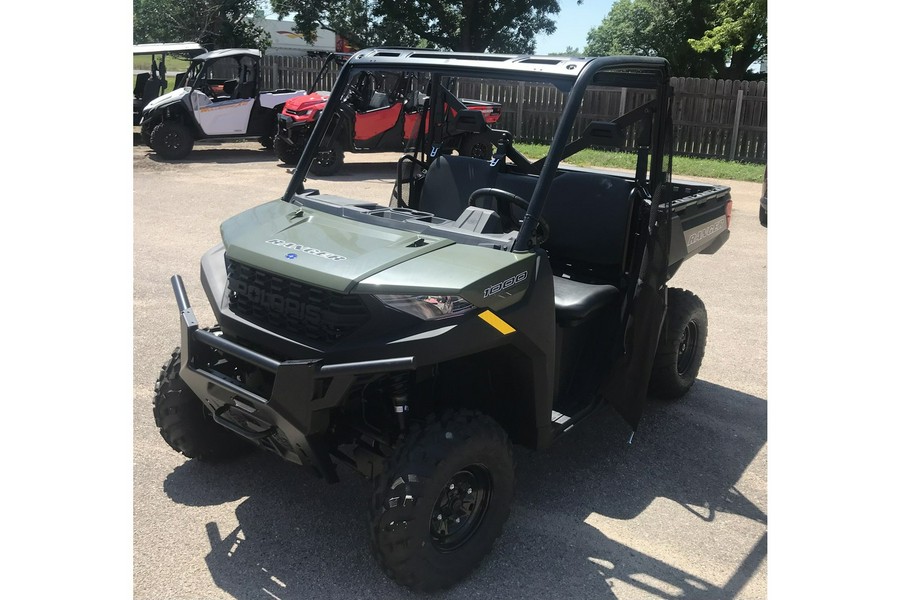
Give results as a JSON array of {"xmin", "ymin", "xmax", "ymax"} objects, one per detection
[{"xmin": 585, "ymin": 0, "xmax": 767, "ymax": 79}]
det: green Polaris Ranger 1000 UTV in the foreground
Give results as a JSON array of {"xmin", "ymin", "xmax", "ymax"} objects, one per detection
[{"xmin": 153, "ymin": 48, "xmax": 731, "ymax": 590}]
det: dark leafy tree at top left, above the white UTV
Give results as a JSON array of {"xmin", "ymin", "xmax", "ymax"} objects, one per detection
[{"xmin": 133, "ymin": 0, "xmax": 272, "ymax": 52}]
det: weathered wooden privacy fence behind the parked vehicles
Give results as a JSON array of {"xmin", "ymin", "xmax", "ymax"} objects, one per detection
[{"xmin": 263, "ymin": 56, "xmax": 768, "ymax": 163}]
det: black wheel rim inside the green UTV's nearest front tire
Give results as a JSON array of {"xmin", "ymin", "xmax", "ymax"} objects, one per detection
[{"xmin": 431, "ymin": 465, "xmax": 493, "ymax": 552}]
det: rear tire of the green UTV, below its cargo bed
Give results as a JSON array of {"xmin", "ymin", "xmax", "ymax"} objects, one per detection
[{"xmin": 649, "ymin": 288, "xmax": 708, "ymax": 399}]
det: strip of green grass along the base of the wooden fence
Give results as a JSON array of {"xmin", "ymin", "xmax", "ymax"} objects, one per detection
[{"xmin": 515, "ymin": 144, "xmax": 766, "ymax": 183}]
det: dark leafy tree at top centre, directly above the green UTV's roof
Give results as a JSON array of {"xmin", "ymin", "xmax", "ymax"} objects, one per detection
[{"xmin": 271, "ymin": 0, "xmax": 581, "ymax": 53}]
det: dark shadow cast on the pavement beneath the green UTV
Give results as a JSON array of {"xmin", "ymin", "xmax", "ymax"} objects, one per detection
[{"xmin": 164, "ymin": 381, "xmax": 767, "ymax": 600}]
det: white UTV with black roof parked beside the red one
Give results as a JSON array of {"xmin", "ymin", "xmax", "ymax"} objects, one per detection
[{"xmin": 140, "ymin": 48, "xmax": 306, "ymax": 159}]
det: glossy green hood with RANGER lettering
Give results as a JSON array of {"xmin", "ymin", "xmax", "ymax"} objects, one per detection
[{"xmin": 221, "ymin": 200, "xmax": 535, "ymax": 308}]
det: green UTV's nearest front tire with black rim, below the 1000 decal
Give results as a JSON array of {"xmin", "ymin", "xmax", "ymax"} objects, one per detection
[{"xmin": 370, "ymin": 411, "xmax": 515, "ymax": 591}]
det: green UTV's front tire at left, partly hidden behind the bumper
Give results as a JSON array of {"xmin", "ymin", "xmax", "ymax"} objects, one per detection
[{"xmin": 153, "ymin": 348, "xmax": 253, "ymax": 461}]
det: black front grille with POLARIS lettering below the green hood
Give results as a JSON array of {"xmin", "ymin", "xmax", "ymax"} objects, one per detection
[{"xmin": 225, "ymin": 257, "xmax": 369, "ymax": 343}]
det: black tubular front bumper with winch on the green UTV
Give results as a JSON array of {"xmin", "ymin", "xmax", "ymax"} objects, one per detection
[{"xmin": 171, "ymin": 275, "xmax": 415, "ymax": 481}]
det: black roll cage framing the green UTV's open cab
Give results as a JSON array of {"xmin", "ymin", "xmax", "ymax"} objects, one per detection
[{"xmin": 282, "ymin": 48, "xmax": 671, "ymax": 252}]
